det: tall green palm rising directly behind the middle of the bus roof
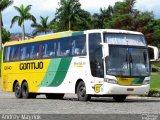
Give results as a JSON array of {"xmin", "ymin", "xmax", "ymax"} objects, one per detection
[{"xmin": 55, "ymin": 0, "xmax": 81, "ymax": 31}]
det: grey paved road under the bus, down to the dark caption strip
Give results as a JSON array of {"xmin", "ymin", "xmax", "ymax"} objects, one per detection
[{"xmin": 0, "ymin": 91, "xmax": 160, "ymax": 114}]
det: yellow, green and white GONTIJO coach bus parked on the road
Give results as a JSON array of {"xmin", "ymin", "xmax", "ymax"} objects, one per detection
[{"xmin": 1, "ymin": 29, "xmax": 150, "ymax": 102}]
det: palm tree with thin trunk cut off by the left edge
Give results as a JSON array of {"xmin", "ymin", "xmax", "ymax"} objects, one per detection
[{"xmin": 0, "ymin": 0, "xmax": 13, "ymax": 51}]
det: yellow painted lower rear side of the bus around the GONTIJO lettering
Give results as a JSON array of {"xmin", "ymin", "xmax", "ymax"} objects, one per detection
[{"xmin": 2, "ymin": 59, "xmax": 50, "ymax": 92}]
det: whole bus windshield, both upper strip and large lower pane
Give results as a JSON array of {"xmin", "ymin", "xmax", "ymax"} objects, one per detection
[{"xmin": 105, "ymin": 34, "xmax": 149, "ymax": 77}]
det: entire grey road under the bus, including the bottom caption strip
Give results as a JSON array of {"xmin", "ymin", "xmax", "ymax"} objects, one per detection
[{"xmin": 0, "ymin": 90, "xmax": 160, "ymax": 120}]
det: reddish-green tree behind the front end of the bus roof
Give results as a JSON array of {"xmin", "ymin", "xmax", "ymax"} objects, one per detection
[{"xmin": 105, "ymin": 0, "xmax": 137, "ymax": 30}]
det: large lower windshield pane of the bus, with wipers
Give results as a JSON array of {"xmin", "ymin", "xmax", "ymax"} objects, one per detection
[{"xmin": 106, "ymin": 46, "xmax": 149, "ymax": 76}]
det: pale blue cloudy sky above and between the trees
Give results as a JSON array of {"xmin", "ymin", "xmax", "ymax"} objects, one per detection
[{"xmin": 2, "ymin": 0, "xmax": 160, "ymax": 33}]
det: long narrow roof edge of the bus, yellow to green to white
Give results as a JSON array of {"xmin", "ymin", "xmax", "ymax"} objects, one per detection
[{"xmin": 4, "ymin": 29, "xmax": 142, "ymax": 46}]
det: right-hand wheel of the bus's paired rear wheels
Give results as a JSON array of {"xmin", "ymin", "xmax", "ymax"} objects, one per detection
[{"xmin": 22, "ymin": 82, "xmax": 30, "ymax": 99}]
